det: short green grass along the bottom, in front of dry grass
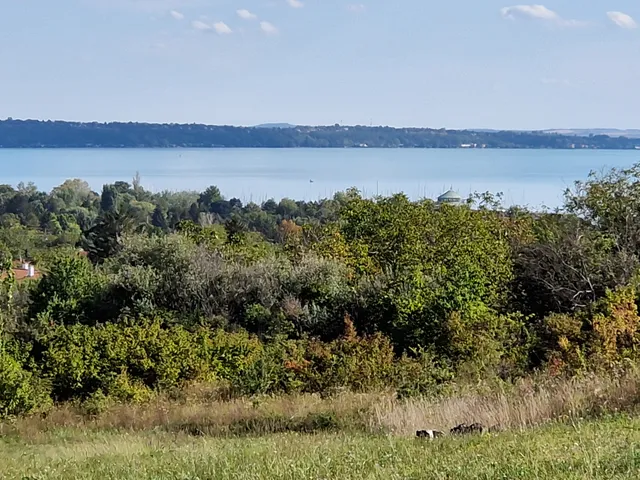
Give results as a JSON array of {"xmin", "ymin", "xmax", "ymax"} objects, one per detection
[{"xmin": 0, "ymin": 415, "xmax": 640, "ymax": 480}]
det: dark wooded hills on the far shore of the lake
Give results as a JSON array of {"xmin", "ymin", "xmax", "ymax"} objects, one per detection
[{"xmin": 0, "ymin": 119, "xmax": 640, "ymax": 149}]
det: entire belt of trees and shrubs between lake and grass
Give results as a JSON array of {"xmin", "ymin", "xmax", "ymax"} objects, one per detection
[{"xmin": 0, "ymin": 165, "xmax": 640, "ymax": 416}]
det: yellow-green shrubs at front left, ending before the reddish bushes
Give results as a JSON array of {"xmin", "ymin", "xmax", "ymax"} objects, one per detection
[{"xmin": 38, "ymin": 320, "xmax": 263, "ymax": 401}]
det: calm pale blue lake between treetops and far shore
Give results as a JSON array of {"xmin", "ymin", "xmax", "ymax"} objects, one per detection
[{"xmin": 0, "ymin": 149, "xmax": 640, "ymax": 207}]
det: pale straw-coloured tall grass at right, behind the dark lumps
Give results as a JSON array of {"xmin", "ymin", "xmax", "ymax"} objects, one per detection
[{"xmin": 370, "ymin": 371, "xmax": 640, "ymax": 435}]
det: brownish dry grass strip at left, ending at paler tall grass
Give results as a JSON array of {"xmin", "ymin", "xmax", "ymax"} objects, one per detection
[{"xmin": 0, "ymin": 386, "xmax": 383, "ymax": 438}]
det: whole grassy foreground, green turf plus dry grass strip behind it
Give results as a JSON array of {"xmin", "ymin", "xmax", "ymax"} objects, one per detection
[{"xmin": 0, "ymin": 375, "xmax": 640, "ymax": 480}]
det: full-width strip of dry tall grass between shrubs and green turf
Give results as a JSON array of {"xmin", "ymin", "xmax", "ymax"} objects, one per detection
[{"xmin": 5, "ymin": 372, "xmax": 640, "ymax": 439}]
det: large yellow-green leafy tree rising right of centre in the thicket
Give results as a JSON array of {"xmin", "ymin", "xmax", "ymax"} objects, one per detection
[{"xmin": 341, "ymin": 195, "xmax": 512, "ymax": 356}]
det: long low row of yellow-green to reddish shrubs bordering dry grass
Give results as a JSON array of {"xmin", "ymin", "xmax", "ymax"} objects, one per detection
[{"xmin": 23, "ymin": 321, "xmax": 447, "ymax": 404}]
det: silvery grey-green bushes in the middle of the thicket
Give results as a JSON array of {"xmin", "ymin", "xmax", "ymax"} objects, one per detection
[{"xmin": 104, "ymin": 232, "xmax": 351, "ymax": 337}]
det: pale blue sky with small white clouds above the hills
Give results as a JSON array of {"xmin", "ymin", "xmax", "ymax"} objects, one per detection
[{"xmin": 0, "ymin": 0, "xmax": 640, "ymax": 129}]
